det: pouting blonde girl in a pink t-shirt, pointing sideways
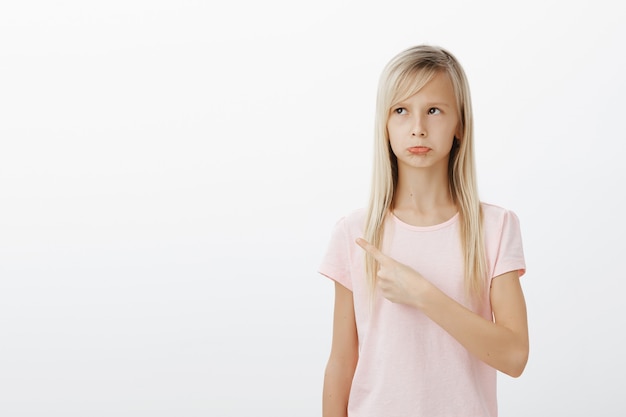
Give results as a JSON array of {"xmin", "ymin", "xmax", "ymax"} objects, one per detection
[{"xmin": 319, "ymin": 45, "xmax": 528, "ymax": 417}]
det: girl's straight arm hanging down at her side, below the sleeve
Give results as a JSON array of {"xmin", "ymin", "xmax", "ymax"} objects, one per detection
[{"xmin": 322, "ymin": 282, "xmax": 359, "ymax": 417}]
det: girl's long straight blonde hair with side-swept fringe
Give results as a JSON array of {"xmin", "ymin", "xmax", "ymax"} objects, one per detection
[{"xmin": 364, "ymin": 45, "xmax": 487, "ymax": 301}]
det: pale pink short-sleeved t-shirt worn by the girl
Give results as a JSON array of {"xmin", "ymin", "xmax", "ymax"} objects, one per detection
[{"xmin": 319, "ymin": 203, "xmax": 526, "ymax": 417}]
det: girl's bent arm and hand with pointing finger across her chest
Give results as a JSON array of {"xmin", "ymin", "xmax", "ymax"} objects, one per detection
[{"xmin": 357, "ymin": 239, "xmax": 529, "ymax": 377}]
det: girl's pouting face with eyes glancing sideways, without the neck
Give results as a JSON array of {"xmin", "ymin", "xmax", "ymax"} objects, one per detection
[{"xmin": 387, "ymin": 72, "xmax": 461, "ymax": 173}]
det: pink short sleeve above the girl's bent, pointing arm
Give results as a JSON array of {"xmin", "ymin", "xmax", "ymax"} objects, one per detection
[{"xmin": 493, "ymin": 210, "xmax": 526, "ymax": 277}]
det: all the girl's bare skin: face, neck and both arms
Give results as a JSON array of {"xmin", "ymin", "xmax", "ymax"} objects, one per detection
[{"xmin": 323, "ymin": 73, "xmax": 529, "ymax": 417}]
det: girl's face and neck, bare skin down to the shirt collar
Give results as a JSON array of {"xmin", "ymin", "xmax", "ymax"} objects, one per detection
[{"xmin": 387, "ymin": 70, "xmax": 461, "ymax": 226}]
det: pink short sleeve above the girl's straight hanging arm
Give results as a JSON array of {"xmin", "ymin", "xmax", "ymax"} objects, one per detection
[{"xmin": 318, "ymin": 218, "xmax": 352, "ymax": 291}]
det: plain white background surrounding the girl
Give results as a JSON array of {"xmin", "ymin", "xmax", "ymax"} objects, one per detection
[{"xmin": 0, "ymin": 0, "xmax": 626, "ymax": 417}]
